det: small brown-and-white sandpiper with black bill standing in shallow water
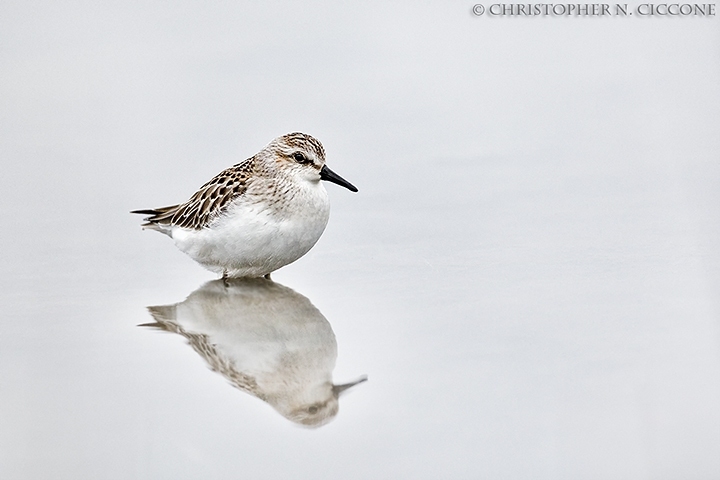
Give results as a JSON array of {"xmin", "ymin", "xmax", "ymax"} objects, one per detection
[{"xmin": 132, "ymin": 133, "xmax": 357, "ymax": 277}]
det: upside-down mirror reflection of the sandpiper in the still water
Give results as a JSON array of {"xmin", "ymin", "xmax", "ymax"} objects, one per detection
[{"xmin": 143, "ymin": 278, "xmax": 366, "ymax": 426}]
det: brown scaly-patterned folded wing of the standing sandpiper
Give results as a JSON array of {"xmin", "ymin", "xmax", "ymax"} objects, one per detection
[{"xmin": 130, "ymin": 158, "xmax": 254, "ymax": 230}]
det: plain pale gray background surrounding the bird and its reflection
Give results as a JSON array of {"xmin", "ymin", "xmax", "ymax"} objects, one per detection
[{"xmin": 0, "ymin": 1, "xmax": 720, "ymax": 479}]
